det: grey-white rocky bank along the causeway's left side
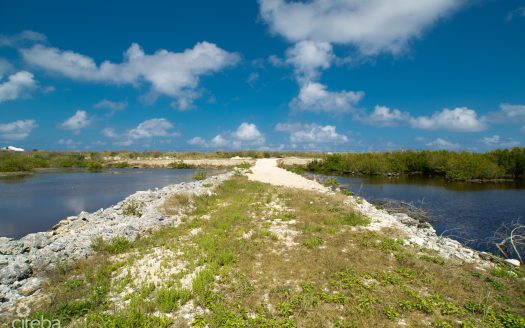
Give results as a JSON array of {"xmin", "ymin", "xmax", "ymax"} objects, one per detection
[{"xmin": 0, "ymin": 172, "xmax": 233, "ymax": 318}]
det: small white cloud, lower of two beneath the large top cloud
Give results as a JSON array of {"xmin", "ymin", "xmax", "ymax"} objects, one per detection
[{"xmin": 290, "ymin": 82, "xmax": 364, "ymax": 113}]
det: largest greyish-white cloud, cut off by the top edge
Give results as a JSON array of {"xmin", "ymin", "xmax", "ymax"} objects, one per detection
[{"xmin": 259, "ymin": 0, "xmax": 464, "ymax": 54}]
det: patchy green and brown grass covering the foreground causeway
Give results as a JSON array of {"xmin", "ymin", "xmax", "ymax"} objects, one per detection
[{"xmin": 17, "ymin": 176, "xmax": 525, "ymax": 327}]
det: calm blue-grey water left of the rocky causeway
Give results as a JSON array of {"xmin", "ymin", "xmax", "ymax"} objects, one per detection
[{"xmin": 0, "ymin": 169, "xmax": 213, "ymax": 238}]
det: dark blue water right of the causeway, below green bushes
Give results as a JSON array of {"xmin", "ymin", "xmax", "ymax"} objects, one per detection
[{"xmin": 308, "ymin": 176, "xmax": 525, "ymax": 250}]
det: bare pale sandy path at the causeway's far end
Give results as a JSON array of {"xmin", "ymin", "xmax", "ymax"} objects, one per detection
[{"xmin": 248, "ymin": 158, "xmax": 328, "ymax": 192}]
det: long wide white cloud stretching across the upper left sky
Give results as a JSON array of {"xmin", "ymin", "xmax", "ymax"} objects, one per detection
[{"xmin": 20, "ymin": 42, "xmax": 240, "ymax": 110}]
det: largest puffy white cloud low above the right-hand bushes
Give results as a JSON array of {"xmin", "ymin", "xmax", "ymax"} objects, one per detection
[{"xmin": 410, "ymin": 107, "xmax": 486, "ymax": 132}]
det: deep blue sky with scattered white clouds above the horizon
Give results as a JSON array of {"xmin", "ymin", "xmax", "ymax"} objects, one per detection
[{"xmin": 0, "ymin": 0, "xmax": 525, "ymax": 151}]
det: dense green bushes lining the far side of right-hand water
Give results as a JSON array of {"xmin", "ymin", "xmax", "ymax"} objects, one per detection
[{"xmin": 306, "ymin": 147, "xmax": 525, "ymax": 181}]
